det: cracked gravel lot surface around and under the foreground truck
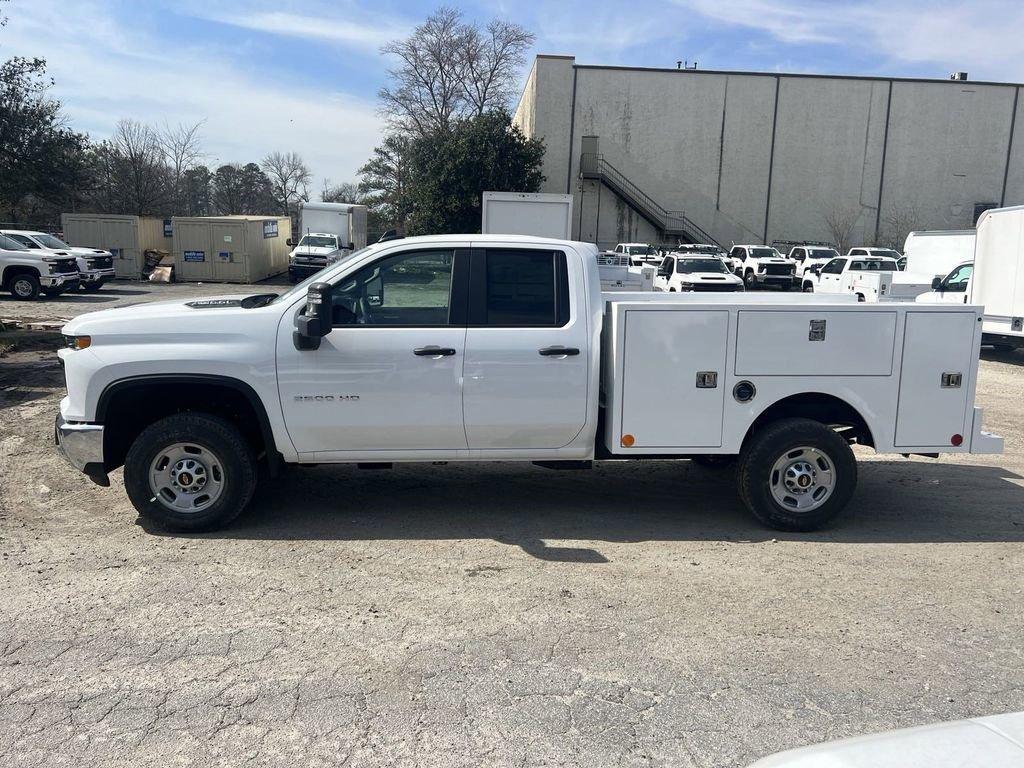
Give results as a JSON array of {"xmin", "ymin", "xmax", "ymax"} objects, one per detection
[{"xmin": 0, "ymin": 284, "xmax": 1024, "ymax": 768}]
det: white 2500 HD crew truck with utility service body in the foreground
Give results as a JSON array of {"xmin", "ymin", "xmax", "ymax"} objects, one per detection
[{"xmin": 55, "ymin": 234, "xmax": 1002, "ymax": 530}]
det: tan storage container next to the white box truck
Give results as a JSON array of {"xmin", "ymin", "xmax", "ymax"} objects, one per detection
[{"xmin": 172, "ymin": 216, "xmax": 292, "ymax": 283}]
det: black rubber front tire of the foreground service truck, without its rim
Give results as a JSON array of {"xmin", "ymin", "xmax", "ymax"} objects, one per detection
[{"xmin": 124, "ymin": 414, "xmax": 257, "ymax": 531}]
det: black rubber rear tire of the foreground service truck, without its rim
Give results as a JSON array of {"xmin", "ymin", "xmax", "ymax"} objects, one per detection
[{"xmin": 736, "ymin": 419, "xmax": 857, "ymax": 531}]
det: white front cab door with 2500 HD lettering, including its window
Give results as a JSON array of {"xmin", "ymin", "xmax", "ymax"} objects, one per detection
[{"xmin": 278, "ymin": 247, "xmax": 469, "ymax": 459}]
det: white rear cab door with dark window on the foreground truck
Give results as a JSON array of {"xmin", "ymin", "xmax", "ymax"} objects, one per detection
[{"xmin": 463, "ymin": 246, "xmax": 591, "ymax": 450}]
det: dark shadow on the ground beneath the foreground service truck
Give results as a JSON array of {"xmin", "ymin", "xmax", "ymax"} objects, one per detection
[{"xmin": 169, "ymin": 460, "xmax": 1024, "ymax": 563}]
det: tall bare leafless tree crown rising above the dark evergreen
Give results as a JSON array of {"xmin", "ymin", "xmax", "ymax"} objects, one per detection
[{"xmin": 378, "ymin": 7, "xmax": 534, "ymax": 136}]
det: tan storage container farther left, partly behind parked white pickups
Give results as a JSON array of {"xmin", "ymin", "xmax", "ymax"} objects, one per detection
[{"xmin": 60, "ymin": 213, "xmax": 171, "ymax": 280}]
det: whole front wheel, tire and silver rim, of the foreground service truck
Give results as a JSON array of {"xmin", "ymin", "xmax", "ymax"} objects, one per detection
[{"xmin": 124, "ymin": 414, "xmax": 256, "ymax": 530}]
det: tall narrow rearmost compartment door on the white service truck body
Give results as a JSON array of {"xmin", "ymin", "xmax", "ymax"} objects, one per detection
[{"xmin": 896, "ymin": 312, "xmax": 977, "ymax": 447}]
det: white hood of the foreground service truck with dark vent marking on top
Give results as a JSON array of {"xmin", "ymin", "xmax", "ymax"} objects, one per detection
[{"xmin": 60, "ymin": 293, "xmax": 280, "ymax": 336}]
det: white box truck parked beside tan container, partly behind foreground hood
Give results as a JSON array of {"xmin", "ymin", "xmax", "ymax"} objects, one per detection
[{"xmin": 288, "ymin": 202, "xmax": 367, "ymax": 283}]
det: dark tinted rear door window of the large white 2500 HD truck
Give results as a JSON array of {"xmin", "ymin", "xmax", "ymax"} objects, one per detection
[{"xmin": 470, "ymin": 250, "xmax": 569, "ymax": 328}]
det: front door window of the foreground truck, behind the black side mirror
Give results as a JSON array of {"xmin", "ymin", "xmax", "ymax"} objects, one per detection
[{"xmin": 331, "ymin": 248, "xmax": 455, "ymax": 327}]
